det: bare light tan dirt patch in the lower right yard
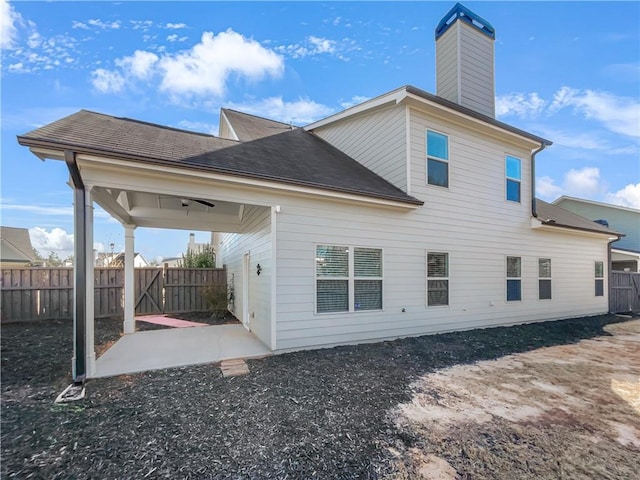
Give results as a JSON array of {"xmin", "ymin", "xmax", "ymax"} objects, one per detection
[{"xmin": 393, "ymin": 320, "xmax": 640, "ymax": 480}]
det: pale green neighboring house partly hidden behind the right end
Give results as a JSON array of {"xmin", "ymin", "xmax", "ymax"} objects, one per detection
[{"xmin": 553, "ymin": 196, "xmax": 640, "ymax": 272}]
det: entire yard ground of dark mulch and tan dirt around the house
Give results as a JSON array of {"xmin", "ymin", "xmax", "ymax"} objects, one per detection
[{"xmin": 0, "ymin": 315, "xmax": 640, "ymax": 480}]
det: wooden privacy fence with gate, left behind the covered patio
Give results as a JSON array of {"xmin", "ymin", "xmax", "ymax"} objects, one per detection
[{"xmin": 0, "ymin": 267, "xmax": 227, "ymax": 322}]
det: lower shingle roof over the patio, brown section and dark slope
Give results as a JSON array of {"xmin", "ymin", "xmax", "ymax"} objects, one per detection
[{"xmin": 18, "ymin": 110, "xmax": 423, "ymax": 205}]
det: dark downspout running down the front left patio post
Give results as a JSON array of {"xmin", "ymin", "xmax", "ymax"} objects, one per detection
[{"xmin": 64, "ymin": 150, "xmax": 87, "ymax": 385}]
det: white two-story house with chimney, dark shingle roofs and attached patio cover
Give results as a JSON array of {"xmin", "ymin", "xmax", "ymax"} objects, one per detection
[{"xmin": 18, "ymin": 4, "xmax": 618, "ymax": 374}]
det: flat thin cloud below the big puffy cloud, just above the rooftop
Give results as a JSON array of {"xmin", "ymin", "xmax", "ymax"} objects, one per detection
[{"xmin": 229, "ymin": 97, "xmax": 334, "ymax": 125}]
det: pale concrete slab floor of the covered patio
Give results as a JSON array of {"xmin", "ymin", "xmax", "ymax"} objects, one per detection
[{"xmin": 93, "ymin": 325, "xmax": 271, "ymax": 378}]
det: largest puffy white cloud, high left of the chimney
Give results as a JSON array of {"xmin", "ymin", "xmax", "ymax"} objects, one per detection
[{"xmin": 159, "ymin": 29, "xmax": 284, "ymax": 96}]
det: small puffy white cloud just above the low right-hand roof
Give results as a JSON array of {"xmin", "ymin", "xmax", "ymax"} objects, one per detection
[{"xmin": 536, "ymin": 167, "xmax": 606, "ymax": 199}]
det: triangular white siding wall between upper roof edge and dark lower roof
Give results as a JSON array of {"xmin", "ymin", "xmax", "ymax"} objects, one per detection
[{"xmin": 313, "ymin": 106, "xmax": 407, "ymax": 191}]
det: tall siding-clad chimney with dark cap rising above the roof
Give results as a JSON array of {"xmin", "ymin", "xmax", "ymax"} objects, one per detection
[{"xmin": 436, "ymin": 3, "xmax": 495, "ymax": 118}]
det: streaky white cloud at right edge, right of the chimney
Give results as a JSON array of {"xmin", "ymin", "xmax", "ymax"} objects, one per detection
[{"xmin": 549, "ymin": 87, "xmax": 640, "ymax": 137}]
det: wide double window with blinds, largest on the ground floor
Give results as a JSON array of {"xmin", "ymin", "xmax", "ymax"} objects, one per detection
[{"xmin": 316, "ymin": 245, "xmax": 382, "ymax": 313}]
